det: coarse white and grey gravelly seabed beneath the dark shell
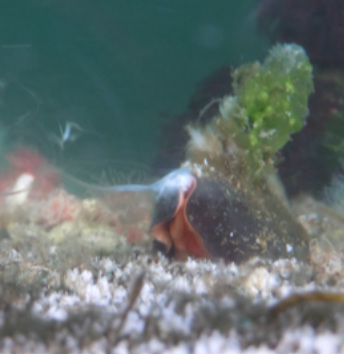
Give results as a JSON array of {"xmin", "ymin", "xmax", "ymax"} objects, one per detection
[{"xmin": 0, "ymin": 194, "xmax": 344, "ymax": 354}]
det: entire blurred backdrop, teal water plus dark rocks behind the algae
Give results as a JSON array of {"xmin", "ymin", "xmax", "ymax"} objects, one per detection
[{"xmin": 0, "ymin": 0, "xmax": 344, "ymax": 198}]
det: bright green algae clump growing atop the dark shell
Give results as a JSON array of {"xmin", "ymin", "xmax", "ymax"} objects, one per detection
[{"xmin": 220, "ymin": 44, "xmax": 313, "ymax": 174}]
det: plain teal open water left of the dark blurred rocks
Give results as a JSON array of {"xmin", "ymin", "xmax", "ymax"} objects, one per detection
[{"xmin": 0, "ymin": 0, "xmax": 270, "ymax": 176}]
